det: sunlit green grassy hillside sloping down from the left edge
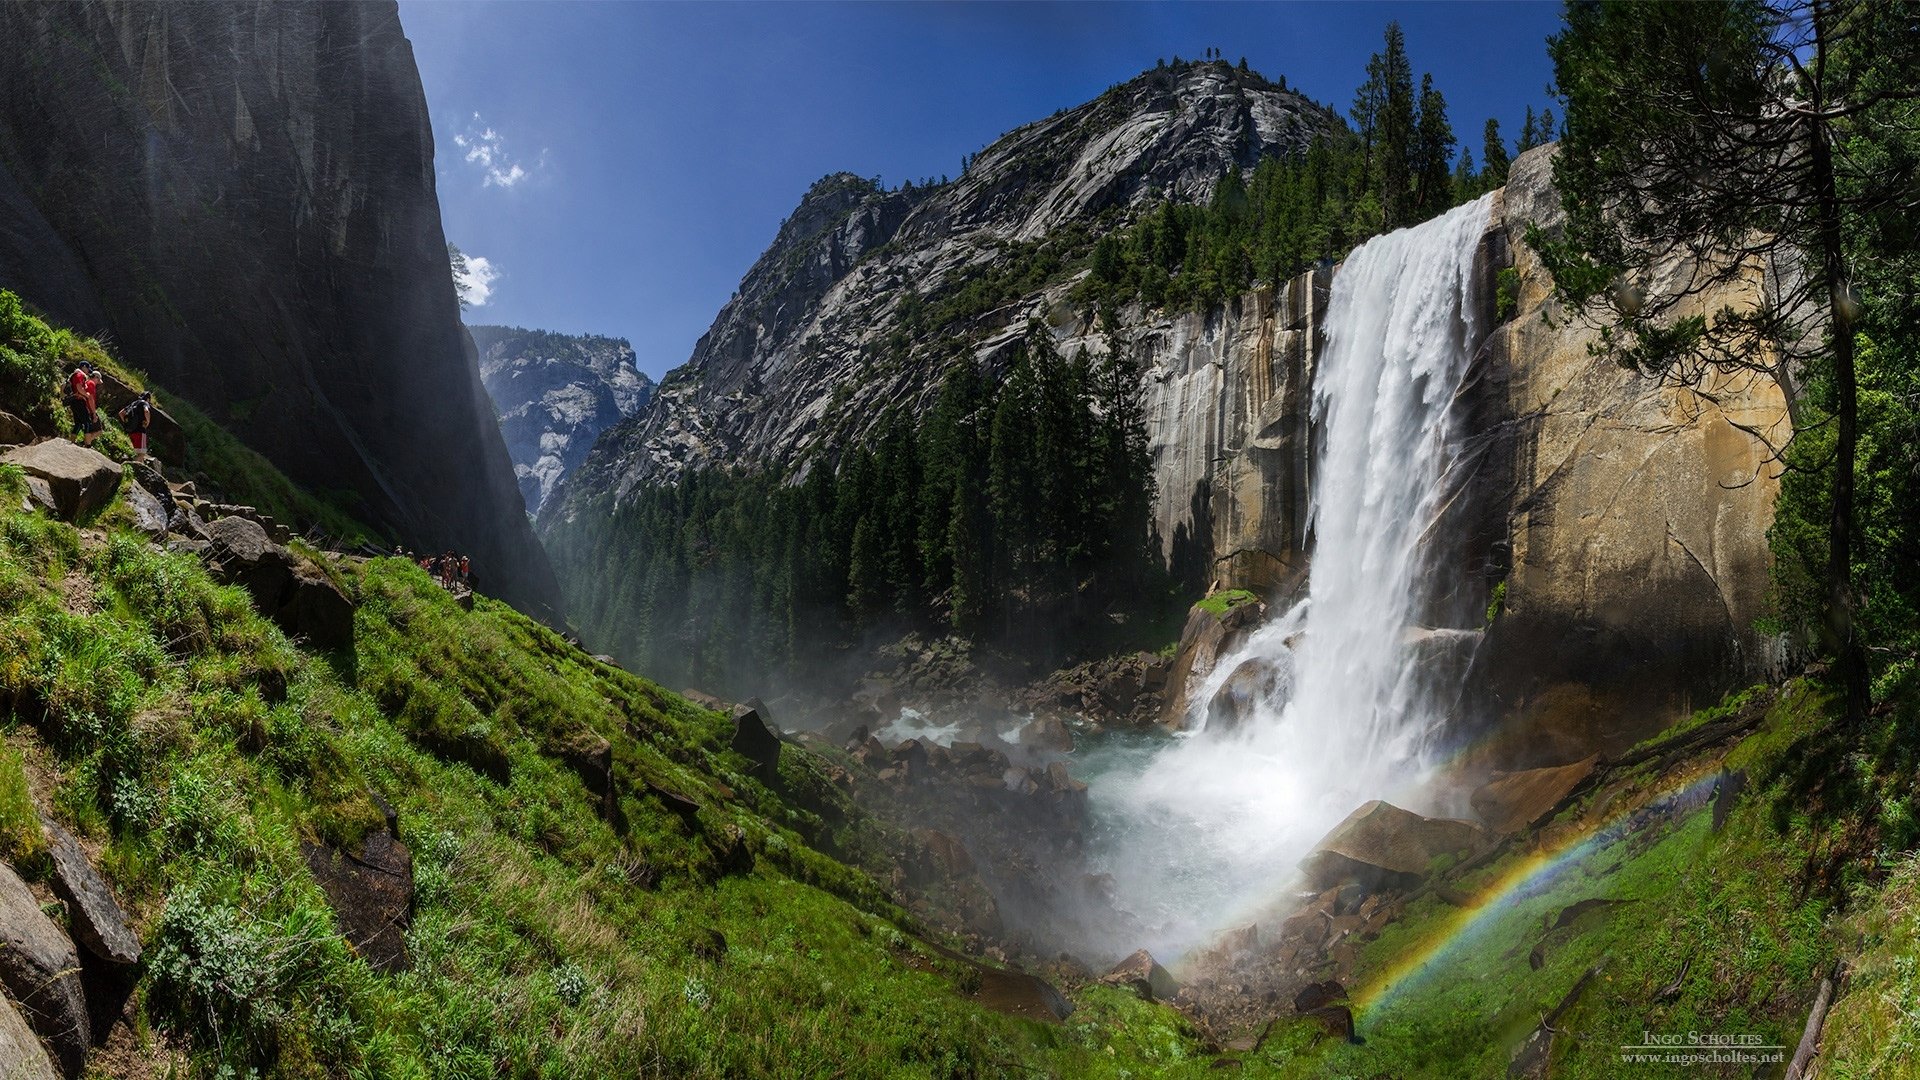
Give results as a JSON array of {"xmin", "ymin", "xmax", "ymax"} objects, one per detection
[{"xmin": 0, "ymin": 474, "xmax": 1236, "ymax": 1076}]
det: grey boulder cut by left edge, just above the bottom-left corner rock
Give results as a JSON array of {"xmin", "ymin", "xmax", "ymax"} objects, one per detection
[{"xmin": 0, "ymin": 863, "xmax": 92, "ymax": 1076}]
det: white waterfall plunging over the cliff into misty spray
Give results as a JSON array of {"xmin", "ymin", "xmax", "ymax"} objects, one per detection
[{"xmin": 1087, "ymin": 196, "xmax": 1490, "ymax": 957}]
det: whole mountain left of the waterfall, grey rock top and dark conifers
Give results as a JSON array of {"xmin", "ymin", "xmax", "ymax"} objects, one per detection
[{"xmin": 541, "ymin": 48, "xmax": 1538, "ymax": 684}]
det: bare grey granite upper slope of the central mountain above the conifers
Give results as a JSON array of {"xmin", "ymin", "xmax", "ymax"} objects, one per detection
[{"xmin": 563, "ymin": 61, "xmax": 1342, "ymax": 503}]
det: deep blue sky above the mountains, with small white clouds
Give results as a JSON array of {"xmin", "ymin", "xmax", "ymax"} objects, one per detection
[{"xmin": 401, "ymin": 0, "xmax": 1559, "ymax": 377}]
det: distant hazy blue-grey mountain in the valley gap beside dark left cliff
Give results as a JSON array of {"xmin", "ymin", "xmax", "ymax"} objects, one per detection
[{"xmin": 467, "ymin": 327, "xmax": 653, "ymax": 513}]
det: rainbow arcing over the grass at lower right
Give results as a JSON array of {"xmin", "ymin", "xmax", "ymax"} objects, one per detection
[{"xmin": 1354, "ymin": 771, "xmax": 1718, "ymax": 1017}]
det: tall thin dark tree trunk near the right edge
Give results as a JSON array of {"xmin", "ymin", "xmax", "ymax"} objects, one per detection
[{"xmin": 1811, "ymin": 4, "xmax": 1872, "ymax": 726}]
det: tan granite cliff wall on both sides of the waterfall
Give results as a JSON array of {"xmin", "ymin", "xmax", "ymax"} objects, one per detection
[{"xmin": 1113, "ymin": 146, "xmax": 1791, "ymax": 767}]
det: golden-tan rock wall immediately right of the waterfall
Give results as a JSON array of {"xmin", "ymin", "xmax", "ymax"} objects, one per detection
[{"xmin": 1463, "ymin": 146, "xmax": 1791, "ymax": 769}]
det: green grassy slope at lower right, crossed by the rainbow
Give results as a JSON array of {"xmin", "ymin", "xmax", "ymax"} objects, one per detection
[{"xmin": 1246, "ymin": 690, "xmax": 1837, "ymax": 1078}]
